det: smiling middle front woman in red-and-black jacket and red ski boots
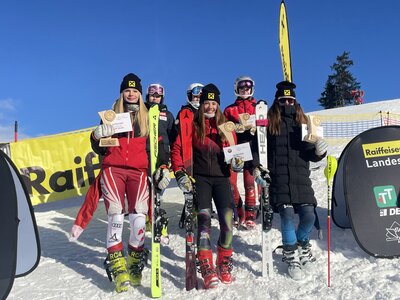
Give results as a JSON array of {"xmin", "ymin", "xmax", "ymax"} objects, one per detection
[{"xmin": 171, "ymin": 84, "xmax": 243, "ymax": 288}]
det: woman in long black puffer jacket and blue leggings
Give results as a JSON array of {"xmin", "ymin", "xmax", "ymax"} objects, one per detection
[{"xmin": 253, "ymin": 81, "xmax": 328, "ymax": 280}]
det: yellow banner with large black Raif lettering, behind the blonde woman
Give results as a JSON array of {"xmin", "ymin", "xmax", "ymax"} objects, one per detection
[{"xmin": 10, "ymin": 129, "xmax": 100, "ymax": 205}]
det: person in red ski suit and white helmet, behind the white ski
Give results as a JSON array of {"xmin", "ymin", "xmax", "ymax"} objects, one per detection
[{"xmin": 224, "ymin": 76, "xmax": 257, "ymax": 229}]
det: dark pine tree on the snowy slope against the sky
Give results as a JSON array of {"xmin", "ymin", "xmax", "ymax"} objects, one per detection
[{"xmin": 318, "ymin": 51, "xmax": 360, "ymax": 109}]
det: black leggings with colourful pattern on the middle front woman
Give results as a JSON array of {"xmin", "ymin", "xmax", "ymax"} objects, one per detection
[{"xmin": 195, "ymin": 175, "xmax": 233, "ymax": 250}]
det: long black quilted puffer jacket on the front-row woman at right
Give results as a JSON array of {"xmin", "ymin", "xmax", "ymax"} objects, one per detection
[{"xmin": 268, "ymin": 106, "xmax": 324, "ymax": 211}]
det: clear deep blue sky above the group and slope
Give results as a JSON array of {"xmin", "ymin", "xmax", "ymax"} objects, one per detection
[{"xmin": 0, "ymin": 0, "xmax": 400, "ymax": 142}]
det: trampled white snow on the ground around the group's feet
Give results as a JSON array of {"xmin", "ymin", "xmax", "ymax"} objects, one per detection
[{"xmin": 8, "ymin": 100, "xmax": 400, "ymax": 300}]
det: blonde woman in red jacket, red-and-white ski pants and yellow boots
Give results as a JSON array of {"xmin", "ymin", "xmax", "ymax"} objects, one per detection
[{"xmin": 90, "ymin": 73, "xmax": 169, "ymax": 292}]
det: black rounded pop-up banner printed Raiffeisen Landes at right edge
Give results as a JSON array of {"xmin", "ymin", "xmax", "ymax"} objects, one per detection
[{"xmin": 335, "ymin": 126, "xmax": 400, "ymax": 258}]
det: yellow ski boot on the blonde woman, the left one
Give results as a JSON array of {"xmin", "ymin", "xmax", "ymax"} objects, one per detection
[{"xmin": 104, "ymin": 251, "xmax": 129, "ymax": 293}]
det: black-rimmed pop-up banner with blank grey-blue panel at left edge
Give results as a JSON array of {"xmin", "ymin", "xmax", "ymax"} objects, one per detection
[{"xmin": 0, "ymin": 151, "xmax": 40, "ymax": 299}]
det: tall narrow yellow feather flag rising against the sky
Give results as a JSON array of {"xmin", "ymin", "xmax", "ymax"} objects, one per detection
[{"xmin": 279, "ymin": 1, "xmax": 292, "ymax": 82}]
